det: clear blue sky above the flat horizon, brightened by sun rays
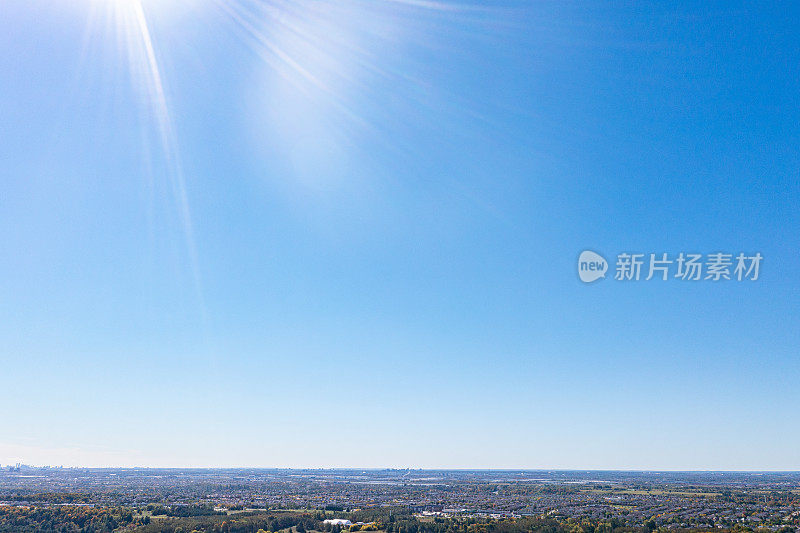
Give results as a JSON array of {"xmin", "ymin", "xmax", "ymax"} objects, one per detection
[{"xmin": 0, "ymin": 0, "xmax": 800, "ymax": 470}]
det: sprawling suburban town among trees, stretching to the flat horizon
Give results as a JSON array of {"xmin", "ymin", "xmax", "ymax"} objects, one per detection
[{"xmin": 0, "ymin": 465, "xmax": 800, "ymax": 533}]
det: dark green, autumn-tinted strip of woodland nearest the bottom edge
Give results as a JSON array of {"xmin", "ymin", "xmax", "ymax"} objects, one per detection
[{"xmin": 0, "ymin": 505, "xmax": 795, "ymax": 533}]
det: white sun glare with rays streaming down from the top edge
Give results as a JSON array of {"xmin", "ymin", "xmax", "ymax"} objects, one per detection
[{"xmin": 87, "ymin": 0, "xmax": 476, "ymax": 300}]
